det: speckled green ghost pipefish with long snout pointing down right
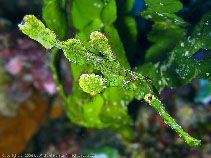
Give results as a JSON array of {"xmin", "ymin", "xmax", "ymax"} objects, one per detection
[{"xmin": 18, "ymin": 15, "xmax": 203, "ymax": 146}]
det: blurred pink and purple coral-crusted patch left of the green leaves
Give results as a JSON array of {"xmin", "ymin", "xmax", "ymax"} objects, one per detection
[{"xmin": 0, "ymin": 33, "xmax": 57, "ymax": 102}]
